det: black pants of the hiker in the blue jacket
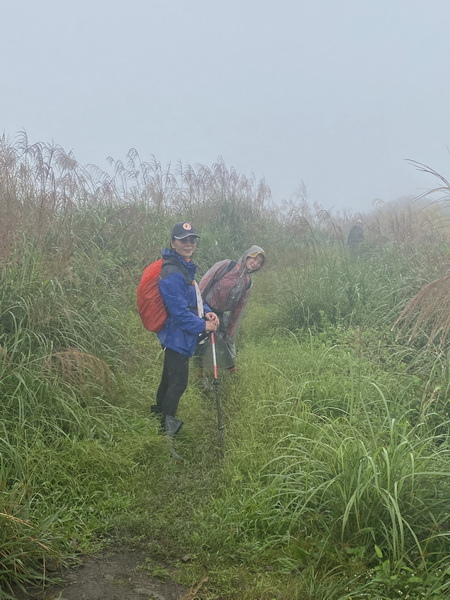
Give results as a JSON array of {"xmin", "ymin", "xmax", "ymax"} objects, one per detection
[{"xmin": 152, "ymin": 348, "xmax": 189, "ymax": 417}]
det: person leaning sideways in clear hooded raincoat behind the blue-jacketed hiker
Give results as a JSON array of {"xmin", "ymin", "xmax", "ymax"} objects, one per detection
[{"xmin": 198, "ymin": 246, "xmax": 266, "ymax": 371}]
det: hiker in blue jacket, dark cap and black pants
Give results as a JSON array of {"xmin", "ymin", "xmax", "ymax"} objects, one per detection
[{"xmin": 151, "ymin": 223, "xmax": 219, "ymax": 460}]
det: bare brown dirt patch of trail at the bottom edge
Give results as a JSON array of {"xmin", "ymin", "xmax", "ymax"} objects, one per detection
[{"xmin": 17, "ymin": 549, "xmax": 193, "ymax": 600}]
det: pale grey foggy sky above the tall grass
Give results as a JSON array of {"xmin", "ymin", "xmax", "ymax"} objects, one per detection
[{"xmin": 0, "ymin": 0, "xmax": 450, "ymax": 211}]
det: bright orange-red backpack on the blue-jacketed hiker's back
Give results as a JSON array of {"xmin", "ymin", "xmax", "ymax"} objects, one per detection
[{"xmin": 136, "ymin": 258, "xmax": 167, "ymax": 333}]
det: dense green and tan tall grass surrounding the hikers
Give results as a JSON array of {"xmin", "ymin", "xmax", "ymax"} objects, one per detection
[{"xmin": 0, "ymin": 135, "xmax": 450, "ymax": 600}]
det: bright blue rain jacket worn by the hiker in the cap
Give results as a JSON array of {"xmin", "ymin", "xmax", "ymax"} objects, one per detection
[{"xmin": 157, "ymin": 248, "xmax": 211, "ymax": 356}]
